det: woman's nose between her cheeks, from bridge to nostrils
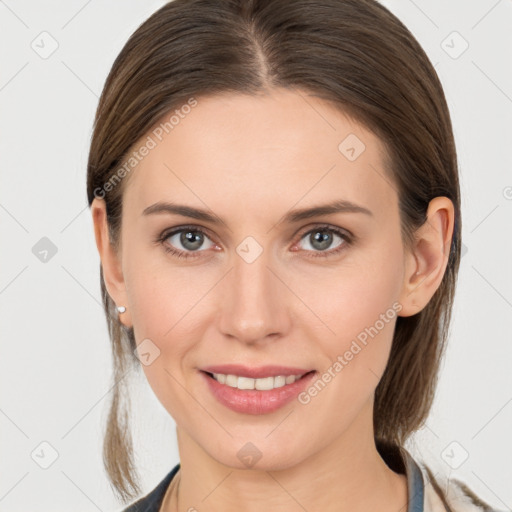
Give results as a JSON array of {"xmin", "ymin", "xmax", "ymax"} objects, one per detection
[{"xmin": 219, "ymin": 245, "xmax": 292, "ymax": 345}]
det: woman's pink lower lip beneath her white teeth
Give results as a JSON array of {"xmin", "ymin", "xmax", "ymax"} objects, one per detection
[{"xmin": 200, "ymin": 371, "xmax": 316, "ymax": 414}]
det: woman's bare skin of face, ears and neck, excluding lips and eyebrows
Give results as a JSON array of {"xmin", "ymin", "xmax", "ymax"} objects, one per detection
[{"xmin": 92, "ymin": 90, "xmax": 454, "ymax": 512}]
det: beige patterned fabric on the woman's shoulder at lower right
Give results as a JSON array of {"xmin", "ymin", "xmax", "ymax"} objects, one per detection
[{"xmin": 419, "ymin": 463, "xmax": 499, "ymax": 512}]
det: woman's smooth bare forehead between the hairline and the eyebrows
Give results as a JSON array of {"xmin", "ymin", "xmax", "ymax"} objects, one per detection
[{"xmin": 124, "ymin": 90, "xmax": 397, "ymax": 221}]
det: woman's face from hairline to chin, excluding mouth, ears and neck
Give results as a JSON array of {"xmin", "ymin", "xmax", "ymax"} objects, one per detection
[{"xmin": 98, "ymin": 90, "xmax": 418, "ymax": 469}]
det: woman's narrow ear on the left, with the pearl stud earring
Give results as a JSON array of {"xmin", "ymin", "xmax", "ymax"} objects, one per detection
[{"xmin": 91, "ymin": 197, "xmax": 131, "ymax": 327}]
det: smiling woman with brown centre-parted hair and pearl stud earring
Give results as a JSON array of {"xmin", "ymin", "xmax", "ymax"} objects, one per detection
[{"xmin": 87, "ymin": 0, "xmax": 500, "ymax": 512}]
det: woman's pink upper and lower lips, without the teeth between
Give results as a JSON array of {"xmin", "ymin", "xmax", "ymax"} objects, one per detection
[{"xmin": 199, "ymin": 366, "xmax": 316, "ymax": 415}]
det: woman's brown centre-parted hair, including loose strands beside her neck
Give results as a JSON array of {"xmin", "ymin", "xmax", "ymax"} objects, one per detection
[{"xmin": 87, "ymin": 0, "xmax": 461, "ymax": 500}]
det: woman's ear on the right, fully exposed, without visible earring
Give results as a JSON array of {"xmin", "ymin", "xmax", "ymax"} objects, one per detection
[{"xmin": 399, "ymin": 196, "xmax": 454, "ymax": 316}]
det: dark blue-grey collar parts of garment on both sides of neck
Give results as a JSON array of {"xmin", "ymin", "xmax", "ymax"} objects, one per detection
[{"xmin": 122, "ymin": 448, "xmax": 424, "ymax": 512}]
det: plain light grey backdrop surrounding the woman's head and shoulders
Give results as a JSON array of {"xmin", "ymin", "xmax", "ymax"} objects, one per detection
[{"xmin": 0, "ymin": 0, "xmax": 512, "ymax": 512}]
